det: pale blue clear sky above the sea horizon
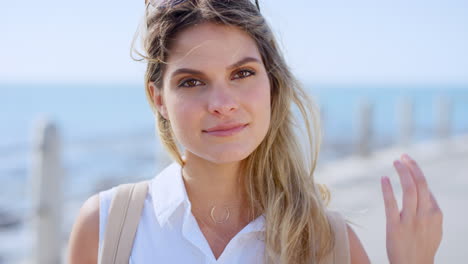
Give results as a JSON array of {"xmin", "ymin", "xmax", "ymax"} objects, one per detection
[{"xmin": 0, "ymin": 0, "xmax": 468, "ymax": 85}]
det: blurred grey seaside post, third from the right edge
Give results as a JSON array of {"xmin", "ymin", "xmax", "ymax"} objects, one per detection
[{"xmin": 356, "ymin": 99, "xmax": 373, "ymax": 156}]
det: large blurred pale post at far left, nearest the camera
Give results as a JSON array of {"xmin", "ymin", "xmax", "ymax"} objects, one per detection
[{"xmin": 31, "ymin": 120, "xmax": 63, "ymax": 264}]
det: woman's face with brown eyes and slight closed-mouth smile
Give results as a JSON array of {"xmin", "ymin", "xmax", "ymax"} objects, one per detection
[{"xmin": 155, "ymin": 23, "xmax": 271, "ymax": 163}]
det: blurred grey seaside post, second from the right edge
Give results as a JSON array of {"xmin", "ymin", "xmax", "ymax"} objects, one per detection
[{"xmin": 397, "ymin": 97, "xmax": 414, "ymax": 147}]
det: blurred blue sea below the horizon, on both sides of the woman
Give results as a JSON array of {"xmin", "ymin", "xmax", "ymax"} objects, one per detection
[{"xmin": 0, "ymin": 84, "xmax": 468, "ymax": 201}]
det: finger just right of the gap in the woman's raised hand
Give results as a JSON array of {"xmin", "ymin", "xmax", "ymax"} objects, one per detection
[{"xmin": 393, "ymin": 160, "xmax": 418, "ymax": 218}]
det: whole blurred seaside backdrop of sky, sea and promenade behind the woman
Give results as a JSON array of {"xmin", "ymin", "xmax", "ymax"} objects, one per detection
[{"xmin": 0, "ymin": 0, "xmax": 468, "ymax": 264}]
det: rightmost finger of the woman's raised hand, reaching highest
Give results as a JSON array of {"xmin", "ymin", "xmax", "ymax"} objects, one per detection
[{"xmin": 402, "ymin": 154, "xmax": 432, "ymax": 212}]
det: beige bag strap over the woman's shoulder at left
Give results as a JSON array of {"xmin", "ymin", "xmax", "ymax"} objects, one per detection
[{"xmin": 98, "ymin": 181, "xmax": 148, "ymax": 264}]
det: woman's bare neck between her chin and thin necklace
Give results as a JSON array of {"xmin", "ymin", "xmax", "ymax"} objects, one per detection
[{"xmin": 183, "ymin": 152, "xmax": 248, "ymax": 223}]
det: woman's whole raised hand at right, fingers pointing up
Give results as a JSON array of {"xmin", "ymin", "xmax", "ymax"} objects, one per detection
[{"xmin": 381, "ymin": 154, "xmax": 443, "ymax": 264}]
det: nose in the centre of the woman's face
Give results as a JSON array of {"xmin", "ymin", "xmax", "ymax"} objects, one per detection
[{"xmin": 208, "ymin": 85, "xmax": 239, "ymax": 117}]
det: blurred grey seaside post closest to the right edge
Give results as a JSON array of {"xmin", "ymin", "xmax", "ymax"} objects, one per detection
[{"xmin": 435, "ymin": 96, "xmax": 452, "ymax": 139}]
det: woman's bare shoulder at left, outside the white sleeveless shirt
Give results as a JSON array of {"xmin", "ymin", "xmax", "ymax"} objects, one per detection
[{"xmin": 67, "ymin": 194, "xmax": 99, "ymax": 264}]
